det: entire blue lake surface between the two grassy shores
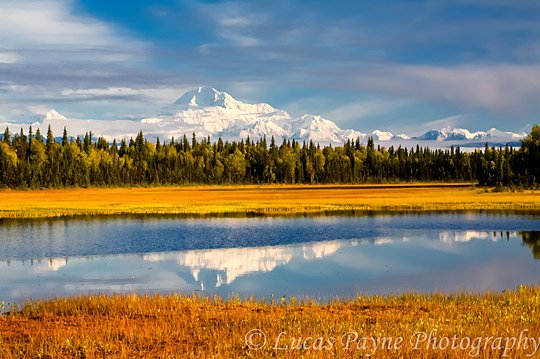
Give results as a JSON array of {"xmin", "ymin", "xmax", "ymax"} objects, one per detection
[{"xmin": 0, "ymin": 213, "xmax": 540, "ymax": 301}]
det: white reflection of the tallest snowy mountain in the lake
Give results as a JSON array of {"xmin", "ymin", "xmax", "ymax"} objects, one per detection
[{"xmin": 143, "ymin": 241, "xmax": 345, "ymax": 287}]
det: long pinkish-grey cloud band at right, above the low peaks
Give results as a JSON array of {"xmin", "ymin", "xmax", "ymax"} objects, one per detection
[{"xmin": 349, "ymin": 64, "xmax": 540, "ymax": 113}]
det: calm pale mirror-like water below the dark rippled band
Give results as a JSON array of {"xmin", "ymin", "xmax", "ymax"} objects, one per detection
[{"xmin": 0, "ymin": 229, "xmax": 538, "ymax": 300}]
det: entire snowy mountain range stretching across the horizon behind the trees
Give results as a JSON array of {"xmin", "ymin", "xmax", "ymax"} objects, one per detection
[{"xmin": 0, "ymin": 87, "xmax": 526, "ymax": 147}]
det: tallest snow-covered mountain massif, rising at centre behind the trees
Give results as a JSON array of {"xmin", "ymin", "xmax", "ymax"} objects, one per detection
[{"xmin": 141, "ymin": 87, "xmax": 365, "ymax": 143}]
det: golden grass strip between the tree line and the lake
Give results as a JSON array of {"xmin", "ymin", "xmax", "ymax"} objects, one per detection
[{"xmin": 0, "ymin": 184, "xmax": 540, "ymax": 218}]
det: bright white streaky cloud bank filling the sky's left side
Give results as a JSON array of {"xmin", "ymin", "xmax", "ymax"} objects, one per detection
[{"xmin": 0, "ymin": 0, "xmax": 171, "ymax": 119}]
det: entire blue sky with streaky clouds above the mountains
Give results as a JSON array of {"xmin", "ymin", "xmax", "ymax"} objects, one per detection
[{"xmin": 0, "ymin": 0, "xmax": 540, "ymax": 134}]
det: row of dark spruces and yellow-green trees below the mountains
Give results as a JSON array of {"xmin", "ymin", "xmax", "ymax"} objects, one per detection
[{"xmin": 0, "ymin": 126, "xmax": 540, "ymax": 188}]
